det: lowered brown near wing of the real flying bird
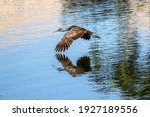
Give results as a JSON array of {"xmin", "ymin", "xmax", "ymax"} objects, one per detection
[{"xmin": 55, "ymin": 28, "xmax": 87, "ymax": 52}]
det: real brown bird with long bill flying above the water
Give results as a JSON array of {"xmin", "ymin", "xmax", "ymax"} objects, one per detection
[{"xmin": 55, "ymin": 26, "xmax": 100, "ymax": 52}]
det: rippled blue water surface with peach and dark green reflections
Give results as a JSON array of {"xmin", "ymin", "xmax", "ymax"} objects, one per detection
[{"xmin": 0, "ymin": 0, "xmax": 150, "ymax": 99}]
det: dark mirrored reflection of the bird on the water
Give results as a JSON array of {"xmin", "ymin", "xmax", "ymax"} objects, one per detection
[{"xmin": 56, "ymin": 54, "xmax": 91, "ymax": 76}]
